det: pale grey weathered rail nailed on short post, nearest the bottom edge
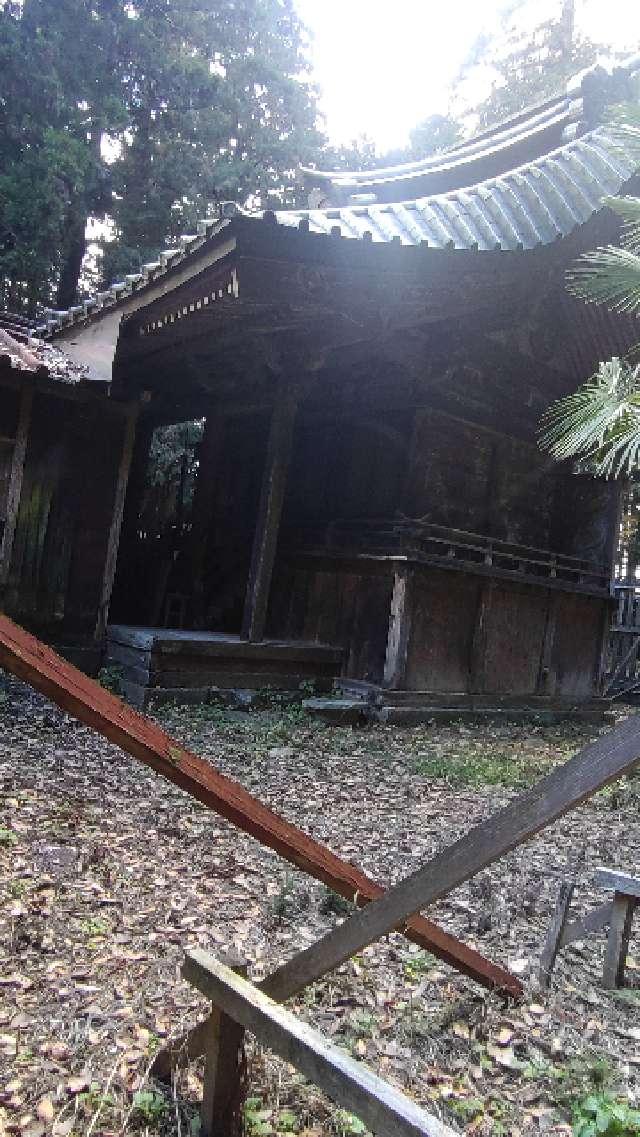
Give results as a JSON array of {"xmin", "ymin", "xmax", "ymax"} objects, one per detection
[{"xmin": 182, "ymin": 951, "xmax": 454, "ymax": 1137}]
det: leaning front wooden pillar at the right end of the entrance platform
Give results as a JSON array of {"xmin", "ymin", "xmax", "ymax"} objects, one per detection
[{"xmin": 242, "ymin": 380, "xmax": 298, "ymax": 642}]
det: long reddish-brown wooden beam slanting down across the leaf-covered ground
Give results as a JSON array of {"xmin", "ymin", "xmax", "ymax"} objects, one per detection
[{"xmin": 0, "ymin": 615, "xmax": 522, "ymax": 998}]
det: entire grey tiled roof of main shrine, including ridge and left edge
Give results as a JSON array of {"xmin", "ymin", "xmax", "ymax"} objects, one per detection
[{"xmin": 27, "ymin": 57, "xmax": 640, "ymax": 338}]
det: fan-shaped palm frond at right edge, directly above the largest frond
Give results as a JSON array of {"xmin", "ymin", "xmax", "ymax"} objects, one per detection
[{"xmin": 567, "ymin": 244, "xmax": 640, "ymax": 313}]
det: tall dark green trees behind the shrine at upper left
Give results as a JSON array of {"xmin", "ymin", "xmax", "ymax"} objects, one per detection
[{"xmin": 0, "ymin": 0, "xmax": 321, "ymax": 310}]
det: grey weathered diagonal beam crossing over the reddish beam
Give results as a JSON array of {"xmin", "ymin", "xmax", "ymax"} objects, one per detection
[{"xmin": 261, "ymin": 716, "xmax": 640, "ymax": 1001}]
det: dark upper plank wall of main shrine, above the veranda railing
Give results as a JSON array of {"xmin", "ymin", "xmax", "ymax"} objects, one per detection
[{"xmin": 283, "ymin": 408, "xmax": 610, "ymax": 561}]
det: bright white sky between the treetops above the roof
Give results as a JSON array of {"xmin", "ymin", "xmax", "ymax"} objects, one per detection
[{"xmin": 296, "ymin": 0, "xmax": 640, "ymax": 152}]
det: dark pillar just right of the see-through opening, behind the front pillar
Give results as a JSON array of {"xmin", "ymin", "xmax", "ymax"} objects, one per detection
[{"xmin": 190, "ymin": 412, "xmax": 224, "ymax": 629}]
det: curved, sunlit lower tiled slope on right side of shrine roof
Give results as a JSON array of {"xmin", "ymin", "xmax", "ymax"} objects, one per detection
[{"xmin": 275, "ymin": 127, "xmax": 640, "ymax": 250}]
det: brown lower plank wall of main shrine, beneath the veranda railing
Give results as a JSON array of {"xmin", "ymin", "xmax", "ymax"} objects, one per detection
[{"xmin": 273, "ymin": 558, "xmax": 608, "ymax": 700}]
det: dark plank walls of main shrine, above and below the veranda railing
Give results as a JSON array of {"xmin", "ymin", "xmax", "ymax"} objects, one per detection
[{"xmin": 263, "ymin": 412, "xmax": 610, "ymax": 699}]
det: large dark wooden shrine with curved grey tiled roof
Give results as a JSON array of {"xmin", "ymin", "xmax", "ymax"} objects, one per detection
[{"xmin": 5, "ymin": 60, "xmax": 640, "ymax": 714}]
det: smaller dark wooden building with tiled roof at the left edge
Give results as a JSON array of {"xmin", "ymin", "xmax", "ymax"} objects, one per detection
[{"xmin": 0, "ymin": 315, "xmax": 136, "ymax": 671}]
